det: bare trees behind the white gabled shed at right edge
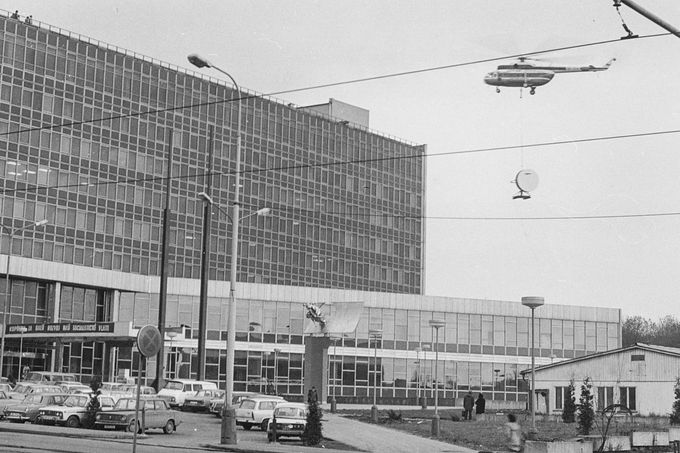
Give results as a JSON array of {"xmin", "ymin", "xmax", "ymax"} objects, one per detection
[{"xmin": 621, "ymin": 315, "xmax": 680, "ymax": 348}]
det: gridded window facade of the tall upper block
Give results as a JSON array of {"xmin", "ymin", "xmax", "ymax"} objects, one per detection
[{"xmin": 0, "ymin": 14, "xmax": 424, "ymax": 294}]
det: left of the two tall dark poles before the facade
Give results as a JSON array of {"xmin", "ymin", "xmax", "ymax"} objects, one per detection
[{"xmin": 156, "ymin": 129, "xmax": 172, "ymax": 391}]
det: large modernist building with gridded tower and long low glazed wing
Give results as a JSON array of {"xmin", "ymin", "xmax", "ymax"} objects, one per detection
[{"xmin": 0, "ymin": 13, "xmax": 621, "ymax": 401}]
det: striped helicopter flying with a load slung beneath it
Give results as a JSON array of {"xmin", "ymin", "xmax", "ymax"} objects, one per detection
[{"xmin": 484, "ymin": 57, "xmax": 616, "ymax": 94}]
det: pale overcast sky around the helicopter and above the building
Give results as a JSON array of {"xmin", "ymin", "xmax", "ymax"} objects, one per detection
[{"xmin": 0, "ymin": 0, "xmax": 680, "ymax": 319}]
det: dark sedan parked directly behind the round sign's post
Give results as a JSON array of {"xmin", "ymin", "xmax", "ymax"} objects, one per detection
[{"xmin": 94, "ymin": 397, "xmax": 182, "ymax": 434}]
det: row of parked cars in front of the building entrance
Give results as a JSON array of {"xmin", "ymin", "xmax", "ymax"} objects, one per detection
[{"xmin": 0, "ymin": 378, "xmax": 307, "ymax": 440}]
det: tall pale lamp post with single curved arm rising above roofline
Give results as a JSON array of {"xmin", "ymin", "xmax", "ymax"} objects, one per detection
[{"xmin": 187, "ymin": 54, "xmax": 242, "ymax": 444}]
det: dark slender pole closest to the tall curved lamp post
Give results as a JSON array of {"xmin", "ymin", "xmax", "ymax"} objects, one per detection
[{"xmin": 197, "ymin": 124, "xmax": 214, "ymax": 381}]
